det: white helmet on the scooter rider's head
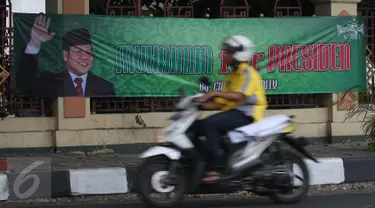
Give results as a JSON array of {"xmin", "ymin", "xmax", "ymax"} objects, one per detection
[{"xmin": 222, "ymin": 35, "xmax": 254, "ymax": 62}]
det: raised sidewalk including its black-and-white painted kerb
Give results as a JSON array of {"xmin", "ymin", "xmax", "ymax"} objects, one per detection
[{"xmin": 0, "ymin": 142, "xmax": 375, "ymax": 200}]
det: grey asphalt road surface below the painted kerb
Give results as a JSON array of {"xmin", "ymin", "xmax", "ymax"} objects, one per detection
[{"xmin": 4, "ymin": 192, "xmax": 375, "ymax": 208}]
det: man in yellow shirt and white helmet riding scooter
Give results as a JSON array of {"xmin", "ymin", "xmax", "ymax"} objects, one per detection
[{"xmin": 196, "ymin": 35, "xmax": 267, "ymax": 182}]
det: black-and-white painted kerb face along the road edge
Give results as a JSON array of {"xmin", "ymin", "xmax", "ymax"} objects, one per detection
[{"xmin": 0, "ymin": 156, "xmax": 375, "ymax": 201}]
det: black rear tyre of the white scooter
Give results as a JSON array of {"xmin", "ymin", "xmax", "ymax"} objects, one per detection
[{"xmin": 270, "ymin": 149, "xmax": 310, "ymax": 204}]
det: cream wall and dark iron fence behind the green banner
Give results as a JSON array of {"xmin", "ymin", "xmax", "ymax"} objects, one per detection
[{"xmin": 0, "ymin": 0, "xmax": 375, "ymax": 152}]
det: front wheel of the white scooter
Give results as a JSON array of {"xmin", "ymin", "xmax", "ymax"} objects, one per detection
[{"xmin": 138, "ymin": 156, "xmax": 186, "ymax": 207}]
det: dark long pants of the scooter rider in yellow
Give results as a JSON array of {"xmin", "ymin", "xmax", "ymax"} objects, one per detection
[{"xmin": 196, "ymin": 109, "xmax": 253, "ymax": 171}]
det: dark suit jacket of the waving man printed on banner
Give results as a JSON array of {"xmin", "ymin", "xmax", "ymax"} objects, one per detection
[{"xmin": 15, "ymin": 50, "xmax": 116, "ymax": 97}]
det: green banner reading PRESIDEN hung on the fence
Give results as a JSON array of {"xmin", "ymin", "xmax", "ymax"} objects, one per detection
[{"xmin": 12, "ymin": 14, "xmax": 366, "ymax": 97}]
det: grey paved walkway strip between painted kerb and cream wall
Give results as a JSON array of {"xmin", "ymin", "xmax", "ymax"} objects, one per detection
[{"xmin": 0, "ymin": 142, "xmax": 374, "ymax": 170}]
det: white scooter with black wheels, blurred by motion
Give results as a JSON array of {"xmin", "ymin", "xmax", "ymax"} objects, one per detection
[{"xmin": 138, "ymin": 77, "xmax": 318, "ymax": 207}]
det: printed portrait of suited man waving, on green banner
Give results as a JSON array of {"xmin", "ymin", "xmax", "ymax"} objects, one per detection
[{"xmin": 15, "ymin": 15, "xmax": 116, "ymax": 97}]
